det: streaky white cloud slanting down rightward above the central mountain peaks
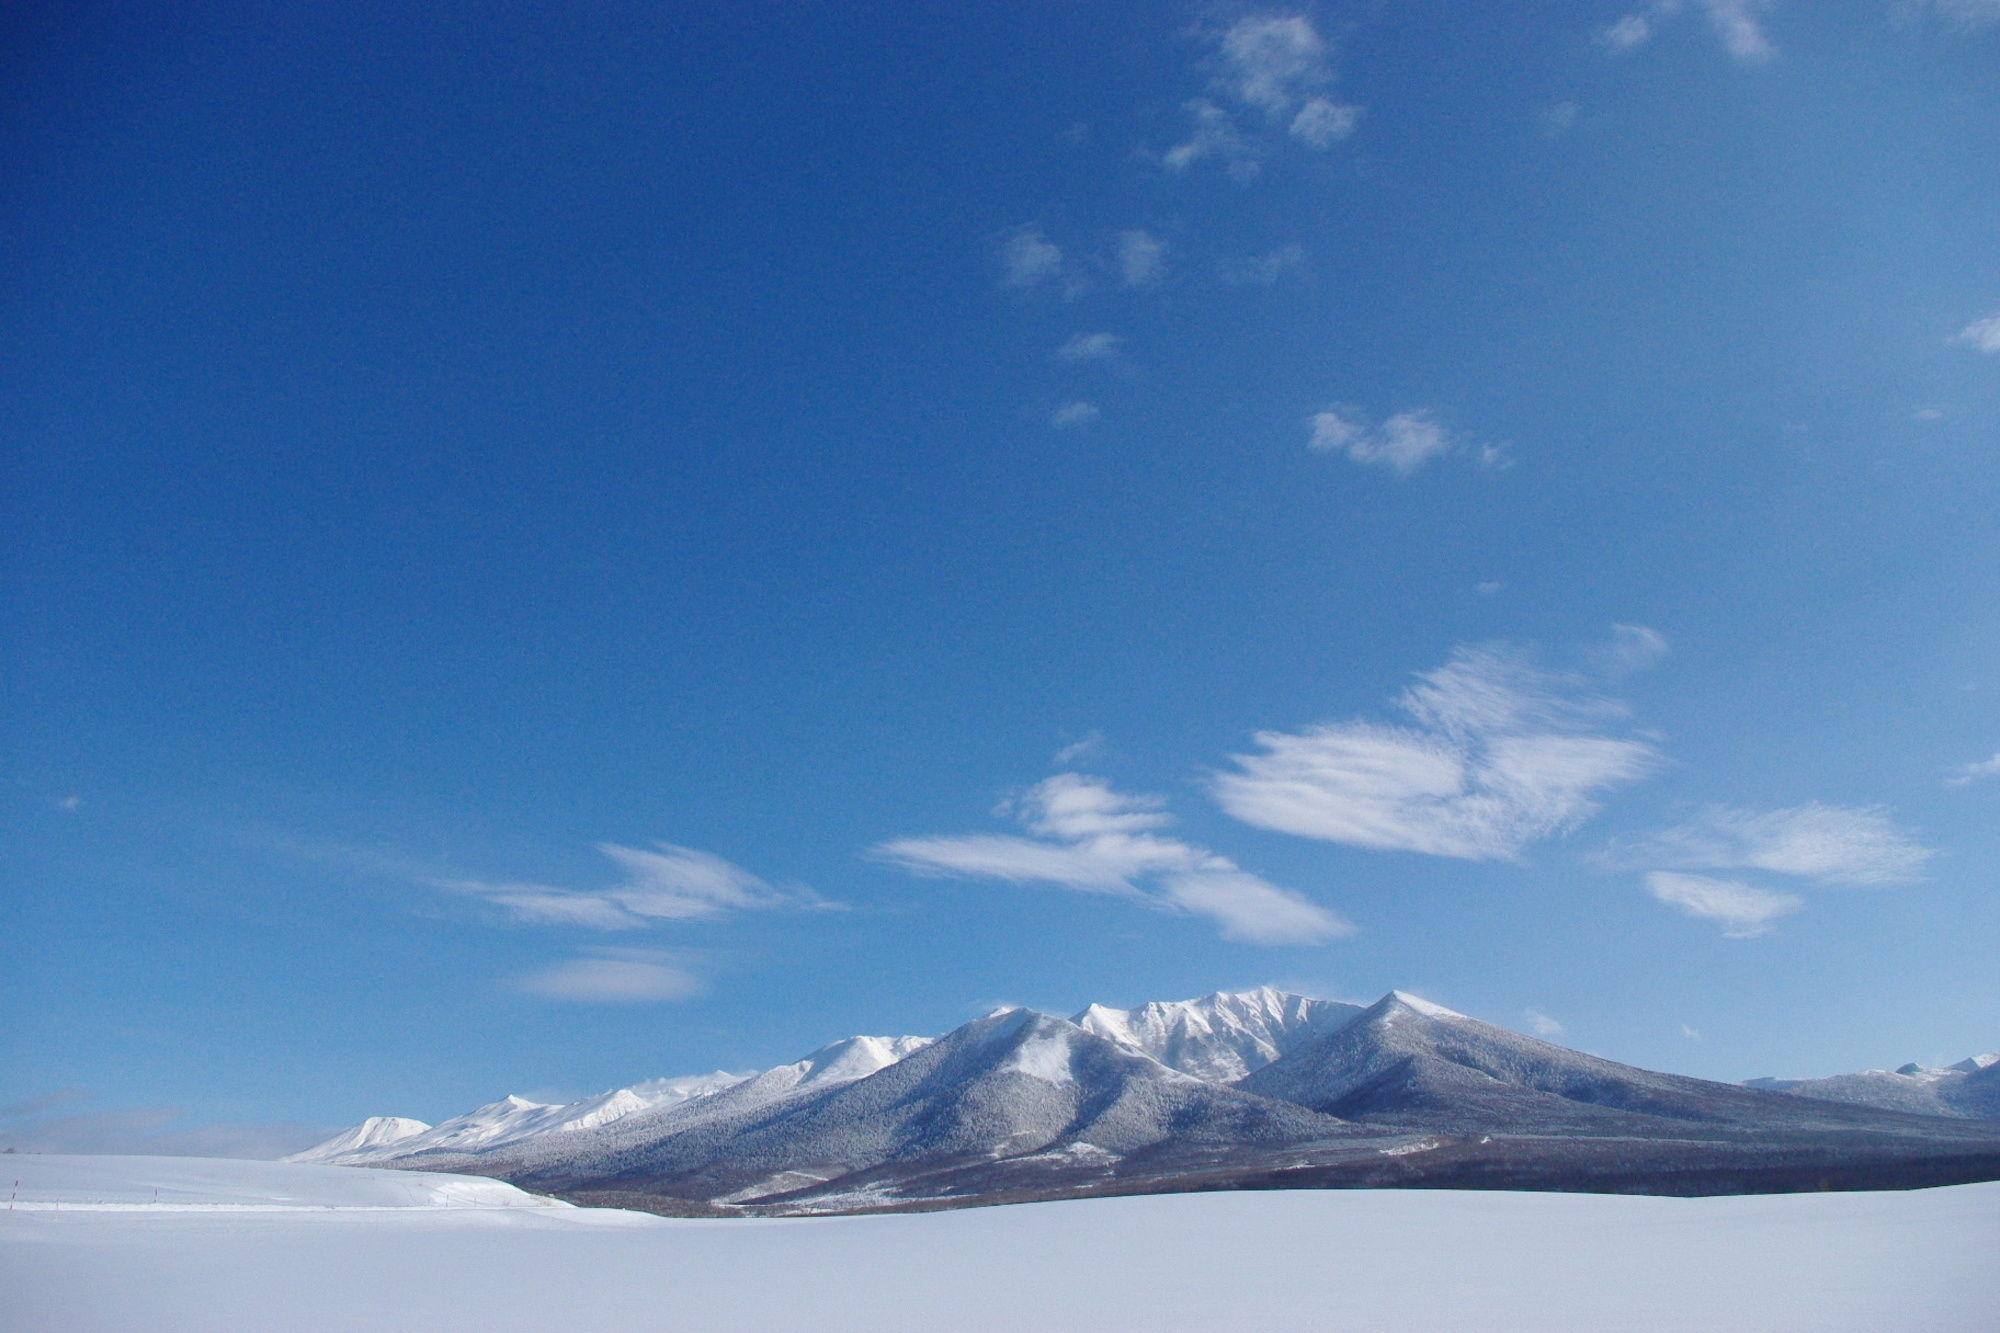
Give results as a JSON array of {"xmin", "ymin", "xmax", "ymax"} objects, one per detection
[{"xmin": 872, "ymin": 773, "xmax": 1352, "ymax": 945}]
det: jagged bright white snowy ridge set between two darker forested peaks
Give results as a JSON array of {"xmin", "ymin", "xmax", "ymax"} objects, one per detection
[{"xmin": 1072, "ymin": 987, "xmax": 1362, "ymax": 1083}]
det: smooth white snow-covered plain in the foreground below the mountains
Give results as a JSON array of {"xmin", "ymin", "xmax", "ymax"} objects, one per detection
[{"xmin": 11, "ymin": 1157, "xmax": 2000, "ymax": 1331}]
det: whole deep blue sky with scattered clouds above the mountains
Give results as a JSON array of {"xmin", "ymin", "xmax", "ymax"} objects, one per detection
[{"xmin": 0, "ymin": 0, "xmax": 2000, "ymax": 1147}]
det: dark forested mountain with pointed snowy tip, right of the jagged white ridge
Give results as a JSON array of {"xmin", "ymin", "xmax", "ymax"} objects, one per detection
[{"xmin": 1238, "ymin": 991, "xmax": 1968, "ymax": 1135}]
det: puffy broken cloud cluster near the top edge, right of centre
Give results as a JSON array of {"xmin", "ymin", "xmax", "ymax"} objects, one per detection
[{"xmin": 1160, "ymin": 14, "xmax": 1362, "ymax": 180}]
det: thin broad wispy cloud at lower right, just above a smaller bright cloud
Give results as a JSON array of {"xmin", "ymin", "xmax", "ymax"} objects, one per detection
[{"xmin": 1622, "ymin": 801, "xmax": 1932, "ymax": 887}]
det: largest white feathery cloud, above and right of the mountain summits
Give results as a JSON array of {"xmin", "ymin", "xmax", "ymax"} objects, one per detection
[{"xmin": 1212, "ymin": 644, "xmax": 1660, "ymax": 861}]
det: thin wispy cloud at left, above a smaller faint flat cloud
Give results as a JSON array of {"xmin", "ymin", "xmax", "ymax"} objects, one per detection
[{"xmin": 442, "ymin": 843, "xmax": 834, "ymax": 931}]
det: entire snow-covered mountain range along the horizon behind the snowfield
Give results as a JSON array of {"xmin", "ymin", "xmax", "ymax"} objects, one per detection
[{"xmin": 292, "ymin": 987, "xmax": 2000, "ymax": 1213}]
